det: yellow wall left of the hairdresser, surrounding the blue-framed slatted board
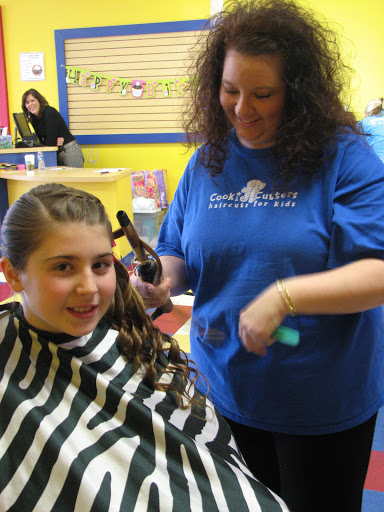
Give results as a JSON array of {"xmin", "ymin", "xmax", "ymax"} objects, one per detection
[{"xmin": 0, "ymin": 0, "xmax": 210, "ymax": 199}]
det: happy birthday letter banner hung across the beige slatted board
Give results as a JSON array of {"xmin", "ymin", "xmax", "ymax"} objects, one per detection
[{"xmin": 64, "ymin": 66, "xmax": 191, "ymax": 98}]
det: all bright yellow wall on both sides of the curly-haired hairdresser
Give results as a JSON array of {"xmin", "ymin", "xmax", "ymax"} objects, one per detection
[{"xmin": 0, "ymin": 0, "xmax": 384, "ymax": 199}]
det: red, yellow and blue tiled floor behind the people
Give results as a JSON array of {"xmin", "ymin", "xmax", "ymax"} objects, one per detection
[{"xmin": 0, "ymin": 273, "xmax": 384, "ymax": 512}]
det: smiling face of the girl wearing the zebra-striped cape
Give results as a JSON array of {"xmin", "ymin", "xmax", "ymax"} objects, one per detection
[{"xmin": 12, "ymin": 222, "xmax": 116, "ymax": 337}]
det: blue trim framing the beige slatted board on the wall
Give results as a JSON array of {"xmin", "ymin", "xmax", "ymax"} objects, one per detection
[{"xmin": 55, "ymin": 19, "xmax": 209, "ymax": 144}]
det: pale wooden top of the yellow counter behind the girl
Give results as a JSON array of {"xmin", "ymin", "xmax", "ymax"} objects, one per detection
[{"xmin": 0, "ymin": 167, "xmax": 133, "ymax": 183}]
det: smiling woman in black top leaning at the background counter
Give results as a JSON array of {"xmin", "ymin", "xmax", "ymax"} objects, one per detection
[{"xmin": 21, "ymin": 89, "xmax": 84, "ymax": 167}]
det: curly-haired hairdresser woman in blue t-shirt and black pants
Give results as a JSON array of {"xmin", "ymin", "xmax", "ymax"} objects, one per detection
[{"xmin": 132, "ymin": 0, "xmax": 384, "ymax": 512}]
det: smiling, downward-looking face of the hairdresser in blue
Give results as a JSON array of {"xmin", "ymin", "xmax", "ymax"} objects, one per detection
[{"xmin": 220, "ymin": 50, "xmax": 285, "ymax": 149}]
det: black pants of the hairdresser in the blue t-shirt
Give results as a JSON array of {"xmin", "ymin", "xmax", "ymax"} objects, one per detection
[{"xmin": 226, "ymin": 414, "xmax": 377, "ymax": 512}]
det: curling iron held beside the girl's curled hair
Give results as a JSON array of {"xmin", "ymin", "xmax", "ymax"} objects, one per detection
[{"xmin": 113, "ymin": 210, "xmax": 173, "ymax": 320}]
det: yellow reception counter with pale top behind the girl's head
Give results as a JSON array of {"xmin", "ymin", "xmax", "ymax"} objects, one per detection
[{"xmin": 0, "ymin": 167, "xmax": 133, "ymax": 259}]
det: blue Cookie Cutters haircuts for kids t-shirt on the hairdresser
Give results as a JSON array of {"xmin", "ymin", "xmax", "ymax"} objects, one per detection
[{"xmin": 156, "ymin": 133, "xmax": 384, "ymax": 434}]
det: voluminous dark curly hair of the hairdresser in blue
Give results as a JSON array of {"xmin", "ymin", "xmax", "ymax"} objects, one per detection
[{"xmin": 184, "ymin": 0, "xmax": 359, "ymax": 181}]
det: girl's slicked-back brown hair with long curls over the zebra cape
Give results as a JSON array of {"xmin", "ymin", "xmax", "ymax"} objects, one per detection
[{"xmin": 1, "ymin": 183, "xmax": 201, "ymax": 408}]
